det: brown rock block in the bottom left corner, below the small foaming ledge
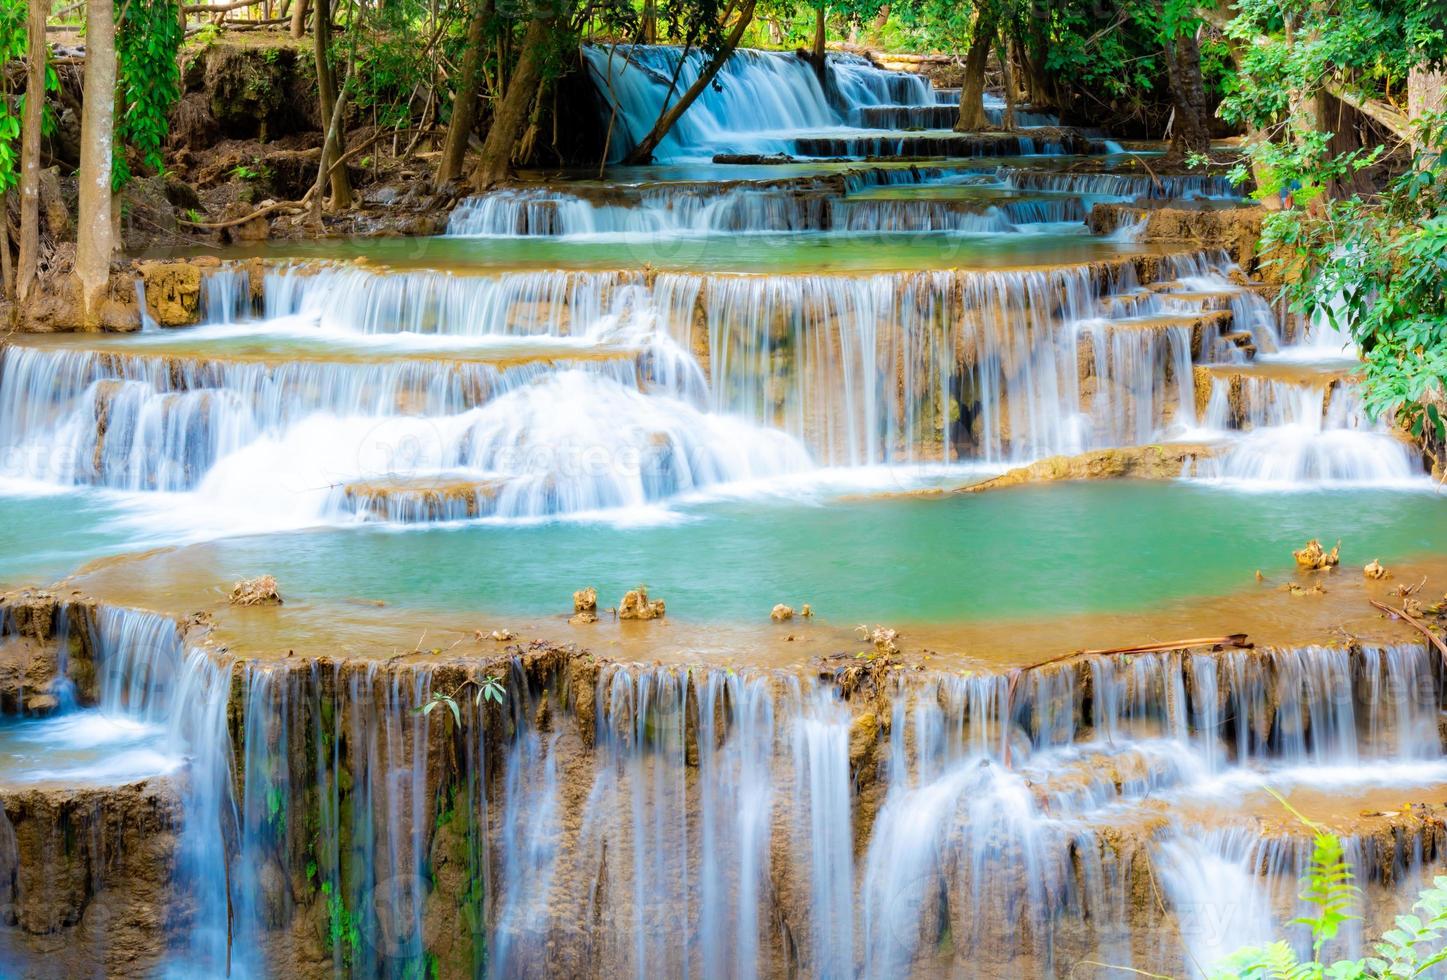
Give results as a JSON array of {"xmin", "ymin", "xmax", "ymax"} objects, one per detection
[{"xmin": 0, "ymin": 779, "xmax": 188, "ymax": 977}]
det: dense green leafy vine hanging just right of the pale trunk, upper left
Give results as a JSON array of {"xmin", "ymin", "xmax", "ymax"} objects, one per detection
[{"xmin": 110, "ymin": 0, "xmax": 181, "ymax": 191}]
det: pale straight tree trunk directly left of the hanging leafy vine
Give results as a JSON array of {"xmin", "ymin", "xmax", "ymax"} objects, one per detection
[{"xmin": 75, "ymin": 0, "xmax": 116, "ymax": 323}]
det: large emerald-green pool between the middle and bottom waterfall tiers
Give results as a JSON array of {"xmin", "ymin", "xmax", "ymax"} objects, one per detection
[{"xmin": 141, "ymin": 482, "xmax": 1447, "ymax": 624}]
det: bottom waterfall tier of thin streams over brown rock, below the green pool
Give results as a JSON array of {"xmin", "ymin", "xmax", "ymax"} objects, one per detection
[{"xmin": 0, "ymin": 587, "xmax": 1447, "ymax": 977}]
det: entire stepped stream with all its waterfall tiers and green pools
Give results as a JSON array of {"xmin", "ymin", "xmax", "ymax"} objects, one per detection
[{"xmin": 0, "ymin": 45, "xmax": 1447, "ymax": 979}]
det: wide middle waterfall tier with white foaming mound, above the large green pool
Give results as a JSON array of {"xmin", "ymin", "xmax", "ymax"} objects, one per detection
[{"xmin": 0, "ymin": 255, "xmax": 1284, "ymax": 525}]
